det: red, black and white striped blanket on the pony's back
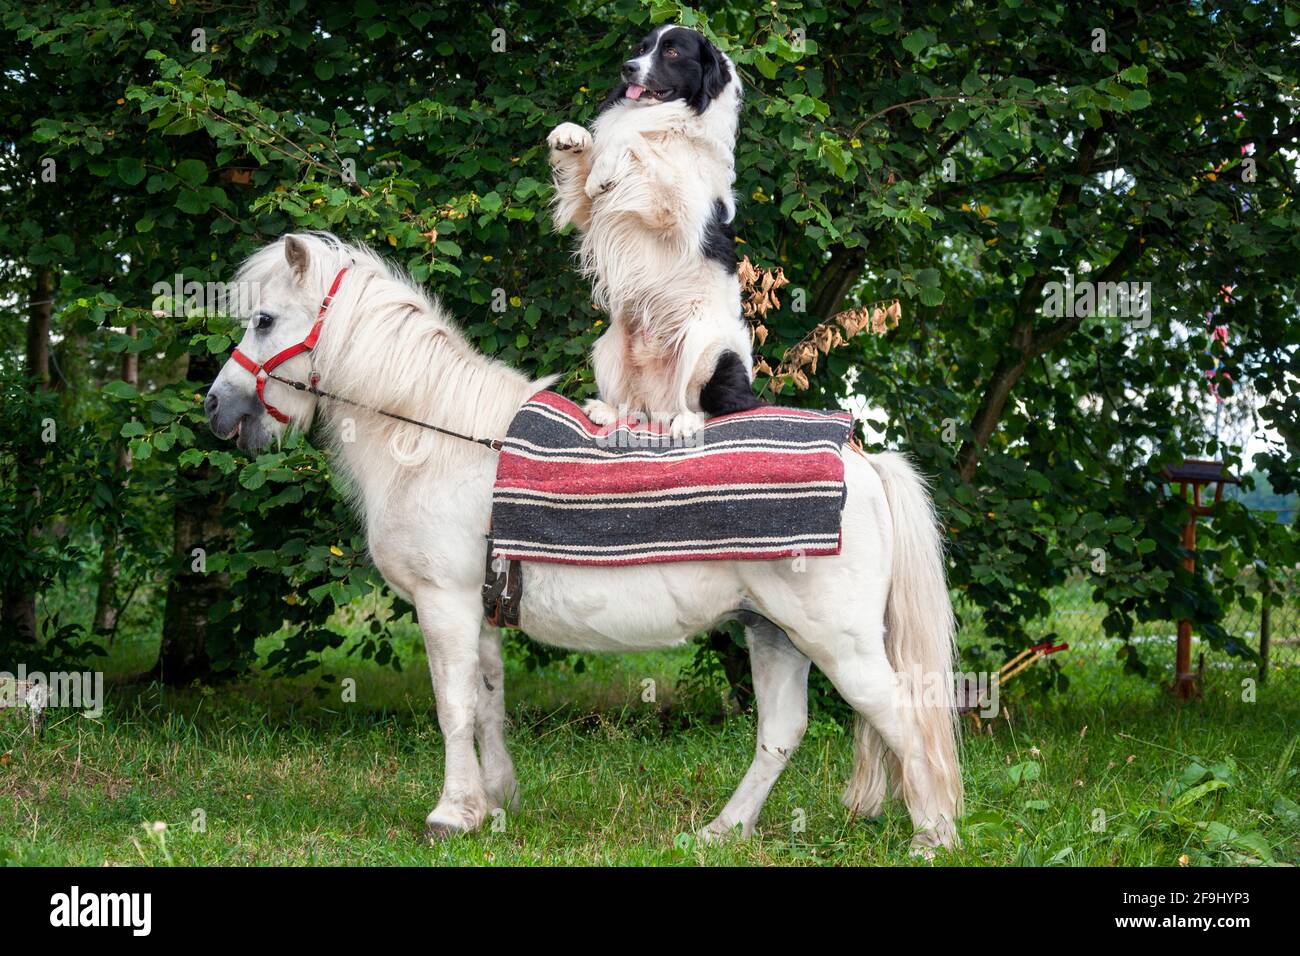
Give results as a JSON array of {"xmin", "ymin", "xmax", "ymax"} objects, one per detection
[{"xmin": 491, "ymin": 392, "xmax": 853, "ymax": 564}]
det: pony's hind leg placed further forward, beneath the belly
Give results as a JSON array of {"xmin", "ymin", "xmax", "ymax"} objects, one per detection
[{"xmin": 701, "ymin": 619, "xmax": 810, "ymax": 840}]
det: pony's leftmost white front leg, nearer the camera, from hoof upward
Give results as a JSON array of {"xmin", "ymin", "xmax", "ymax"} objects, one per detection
[{"xmin": 415, "ymin": 588, "xmax": 489, "ymax": 839}]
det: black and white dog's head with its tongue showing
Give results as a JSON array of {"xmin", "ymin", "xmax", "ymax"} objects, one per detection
[{"xmin": 606, "ymin": 25, "xmax": 736, "ymax": 113}]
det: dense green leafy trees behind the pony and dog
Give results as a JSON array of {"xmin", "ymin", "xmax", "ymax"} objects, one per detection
[{"xmin": 0, "ymin": 0, "xmax": 1300, "ymax": 674}]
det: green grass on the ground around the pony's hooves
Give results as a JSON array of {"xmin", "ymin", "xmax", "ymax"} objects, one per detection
[{"xmin": 0, "ymin": 621, "xmax": 1300, "ymax": 866}]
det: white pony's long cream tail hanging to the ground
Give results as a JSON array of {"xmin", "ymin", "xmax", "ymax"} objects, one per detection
[{"xmin": 850, "ymin": 454, "xmax": 962, "ymax": 845}]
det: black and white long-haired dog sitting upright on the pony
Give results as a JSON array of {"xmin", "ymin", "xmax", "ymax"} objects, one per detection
[{"xmin": 547, "ymin": 26, "xmax": 759, "ymax": 436}]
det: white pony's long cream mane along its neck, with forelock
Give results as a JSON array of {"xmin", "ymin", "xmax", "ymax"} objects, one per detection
[{"xmin": 237, "ymin": 233, "xmax": 551, "ymax": 466}]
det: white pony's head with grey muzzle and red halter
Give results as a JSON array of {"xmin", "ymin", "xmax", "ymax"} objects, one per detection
[{"xmin": 203, "ymin": 234, "xmax": 347, "ymax": 451}]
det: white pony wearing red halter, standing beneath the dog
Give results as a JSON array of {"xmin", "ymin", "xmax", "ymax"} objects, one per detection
[{"xmin": 197, "ymin": 234, "xmax": 962, "ymax": 852}]
